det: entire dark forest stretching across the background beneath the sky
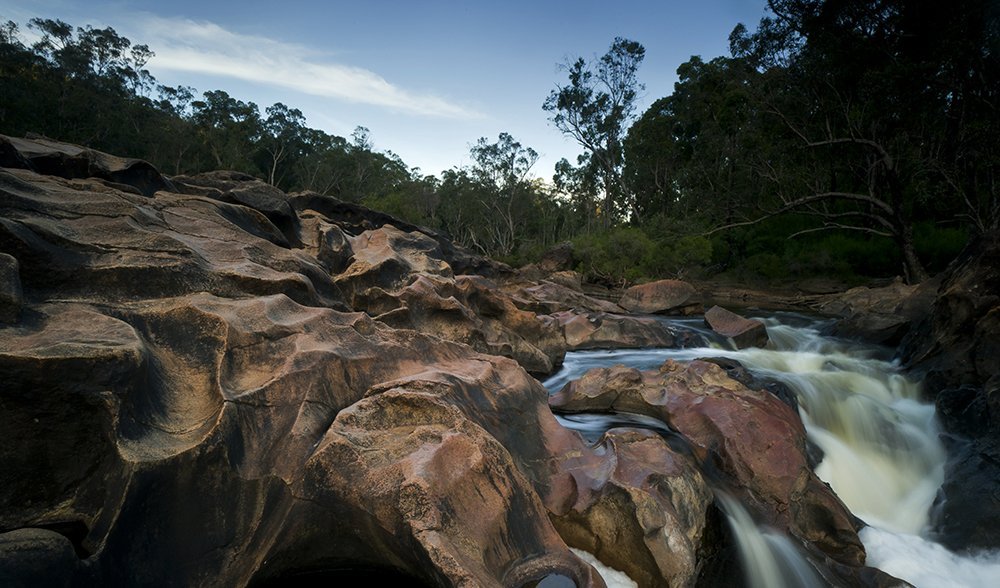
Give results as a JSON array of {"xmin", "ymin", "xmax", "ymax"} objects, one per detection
[{"xmin": 0, "ymin": 0, "xmax": 1000, "ymax": 285}]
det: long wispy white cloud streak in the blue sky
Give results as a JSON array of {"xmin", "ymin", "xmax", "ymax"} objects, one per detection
[{"xmin": 136, "ymin": 16, "xmax": 483, "ymax": 119}]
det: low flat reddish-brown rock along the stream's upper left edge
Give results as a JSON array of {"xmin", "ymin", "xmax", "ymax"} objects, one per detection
[{"xmin": 552, "ymin": 311, "xmax": 676, "ymax": 350}]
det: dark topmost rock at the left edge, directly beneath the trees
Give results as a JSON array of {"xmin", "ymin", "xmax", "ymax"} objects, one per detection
[{"xmin": 0, "ymin": 135, "xmax": 175, "ymax": 196}]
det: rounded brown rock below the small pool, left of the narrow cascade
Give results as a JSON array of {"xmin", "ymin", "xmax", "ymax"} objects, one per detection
[{"xmin": 553, "ymin": 429, "xmax": 714, "ymax": 586}]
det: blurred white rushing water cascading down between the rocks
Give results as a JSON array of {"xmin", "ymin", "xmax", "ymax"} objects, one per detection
[{"xmin": 545, "ymin": 314, "xmax": 1000, "ymax": 588}]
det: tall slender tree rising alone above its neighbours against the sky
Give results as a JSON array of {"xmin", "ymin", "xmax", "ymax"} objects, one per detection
[{"xmin": 542, "ymin": 37, "xmax": 646, "ymax": 226}]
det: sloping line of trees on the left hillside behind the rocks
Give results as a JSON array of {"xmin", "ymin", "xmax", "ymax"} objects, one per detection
[{"xmin": 0, "ymin": 19, "xmax": 575, "ymax": 261}]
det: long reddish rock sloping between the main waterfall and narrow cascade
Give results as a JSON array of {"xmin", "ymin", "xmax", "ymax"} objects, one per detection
[{"xmin": 549, "ymin": 361, "xmax": 896, "ymax": 584}]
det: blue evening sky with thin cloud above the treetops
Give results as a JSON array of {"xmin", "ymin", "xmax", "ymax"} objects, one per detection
[{"xmin": 0, "ymin": 0, "xmax": 766, "ymax": 179}]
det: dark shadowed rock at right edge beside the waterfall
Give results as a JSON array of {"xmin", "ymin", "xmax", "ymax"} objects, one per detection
[{"xmin": 902, "ymin": 231, "xmax": 1000, "ymax": 549}]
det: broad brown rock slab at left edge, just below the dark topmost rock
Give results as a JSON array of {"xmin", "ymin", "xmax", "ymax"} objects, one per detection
[{"xmin": 0, "ymin": 170, "xmax": 346, "ymax": 309}]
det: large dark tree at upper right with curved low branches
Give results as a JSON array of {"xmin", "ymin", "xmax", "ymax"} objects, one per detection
[{"xmin": 712, "ymin": 0, "xmax": 1000, "ymax": 281}]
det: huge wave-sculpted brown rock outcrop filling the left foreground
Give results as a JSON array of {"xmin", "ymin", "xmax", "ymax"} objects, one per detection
[{"xmin": 0, "ymin": 137, "xmax": 603, "ymax": 586}]
